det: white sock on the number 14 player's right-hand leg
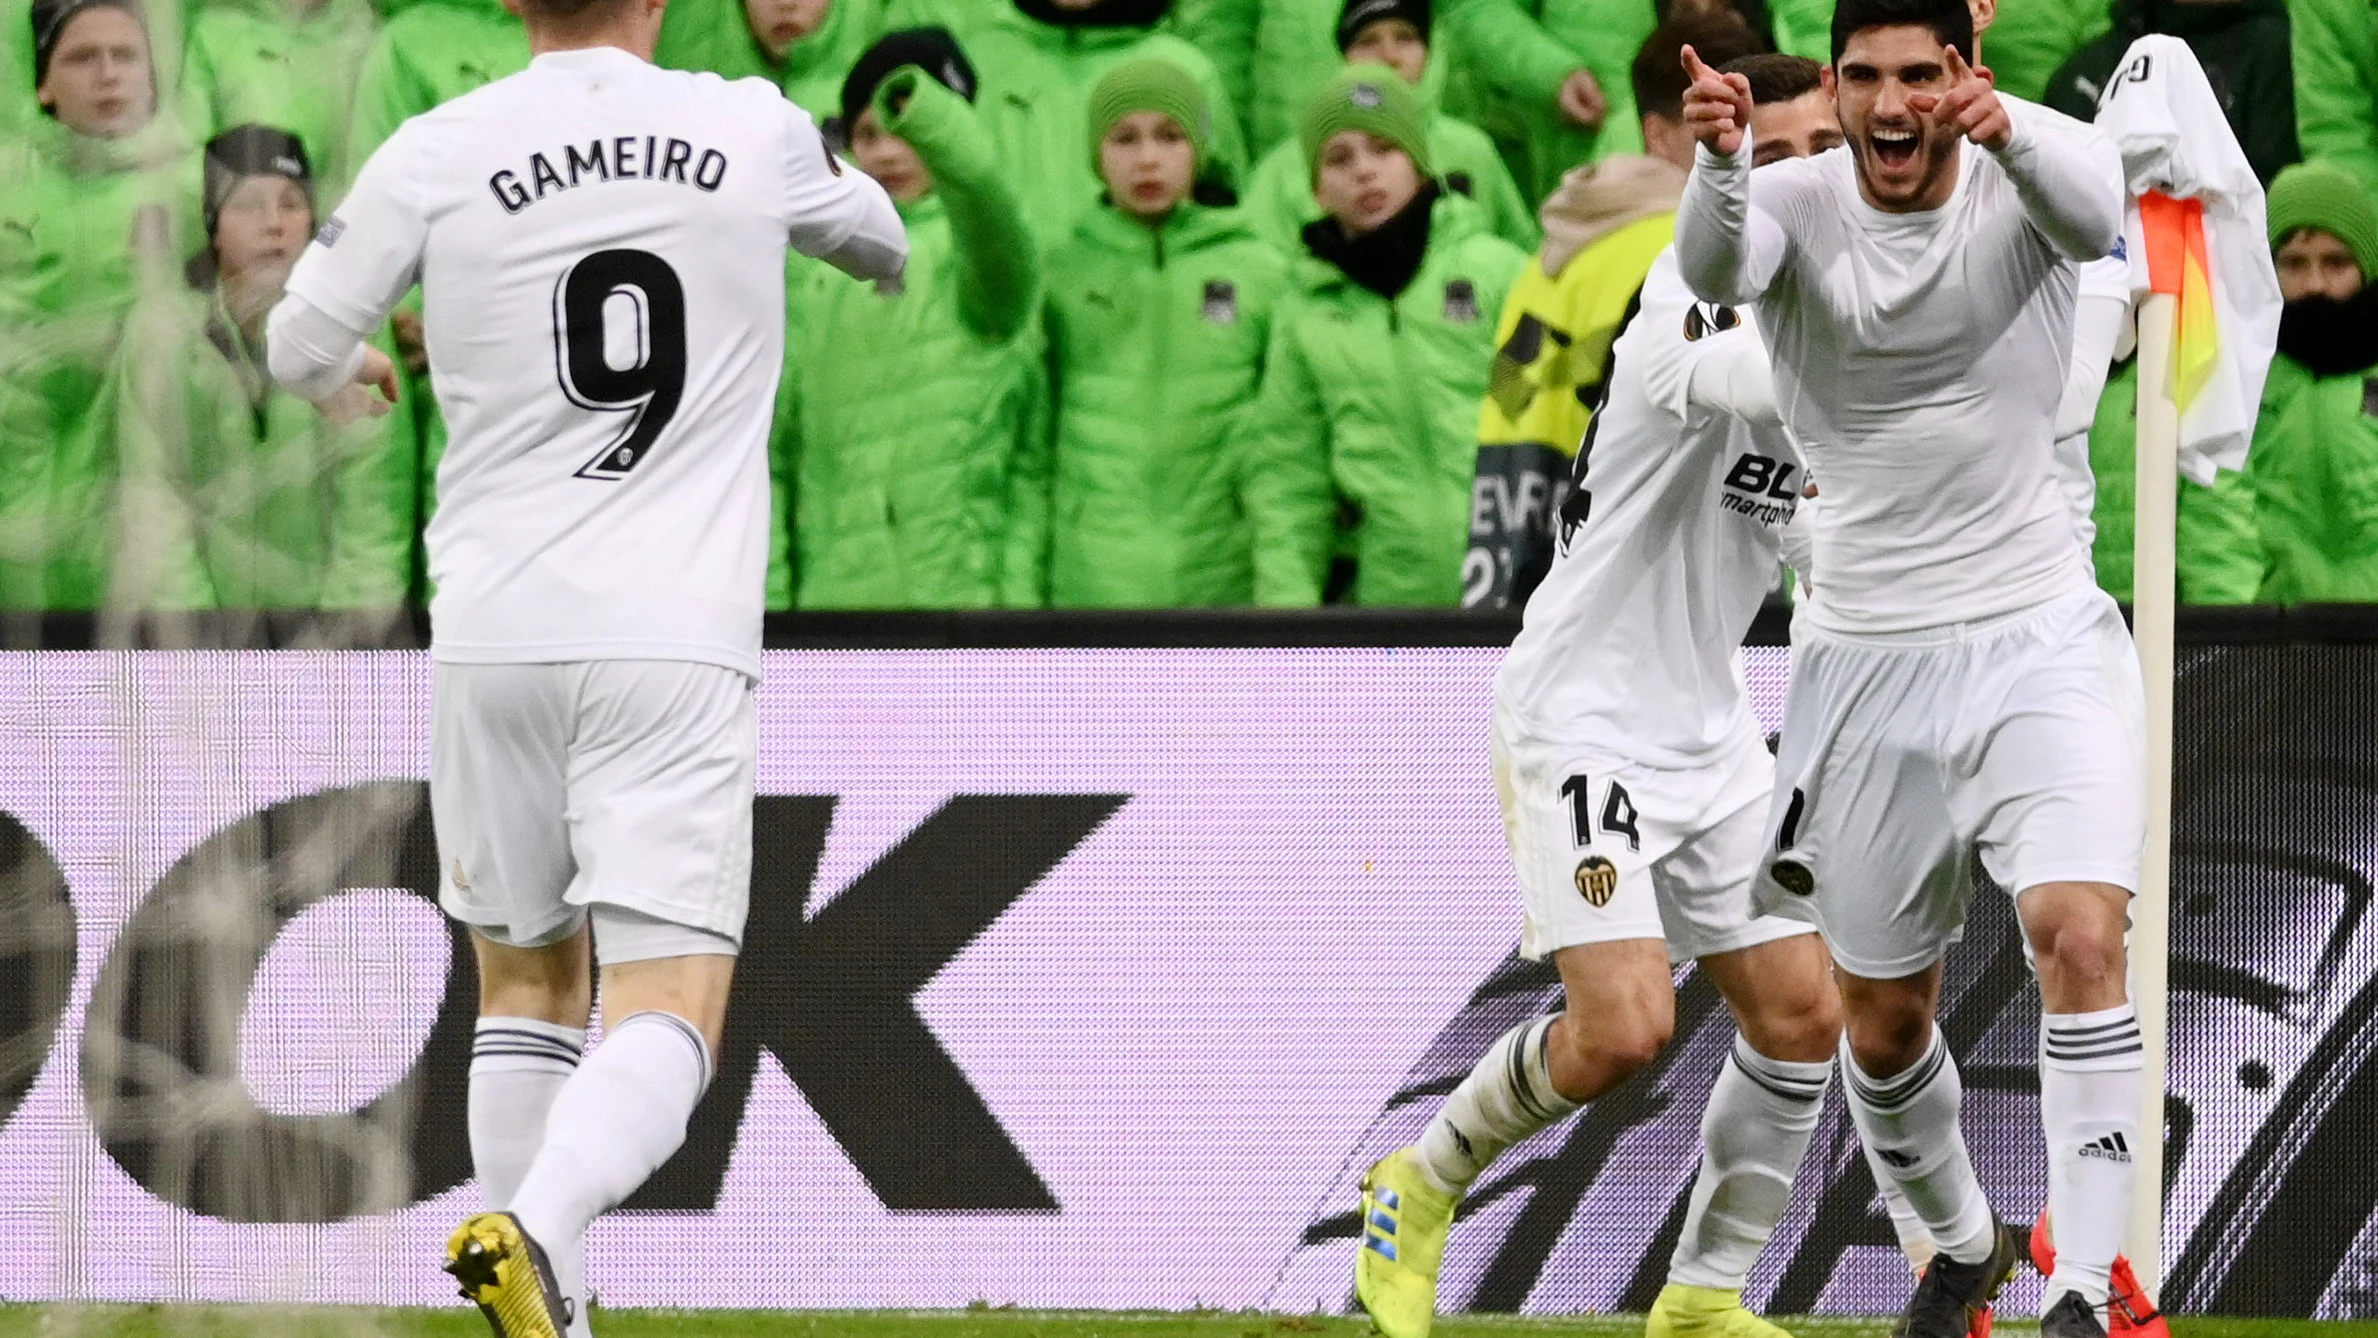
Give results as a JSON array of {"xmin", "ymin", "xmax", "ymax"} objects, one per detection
[{"xmin": 1667, "ymin": 1036, "xmax": 1833, "ymax": 1290}]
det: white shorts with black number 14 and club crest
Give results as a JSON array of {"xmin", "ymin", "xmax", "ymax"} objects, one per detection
[{"xmin": 1493, "ymin": 711, "xmax": 1810, "ymax": 963}]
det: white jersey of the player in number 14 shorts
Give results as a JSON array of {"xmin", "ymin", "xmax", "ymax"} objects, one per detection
[{"xmin": 1496, "ymin": 250, "xmax": 1805, "ymax": 768}]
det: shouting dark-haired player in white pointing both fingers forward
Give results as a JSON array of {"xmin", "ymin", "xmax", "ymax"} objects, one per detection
[{"xmin": 1676, "ymin": 0, "xmax": 2162, "ymax": 1338}]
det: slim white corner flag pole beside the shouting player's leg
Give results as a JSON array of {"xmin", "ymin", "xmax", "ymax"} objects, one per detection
[{"xmin": 2124, "ymin": 292, "xmax": 2181, "ymax": 1298}]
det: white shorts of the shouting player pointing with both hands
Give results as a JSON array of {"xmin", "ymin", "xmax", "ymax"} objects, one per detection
[{"xmin": 1757, "ymin": 589, "xmax": 2147, "ymax": 979}]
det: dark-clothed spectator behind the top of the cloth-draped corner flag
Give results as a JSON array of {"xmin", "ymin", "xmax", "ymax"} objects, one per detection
[{"xmin": 2047, "ymin": 0, "xmax": 2304, "ymax": 183}]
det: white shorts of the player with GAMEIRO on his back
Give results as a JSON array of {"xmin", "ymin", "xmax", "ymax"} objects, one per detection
[{"xmin": 430, "ymin": 661, "xmax": 759, "ymax": 951}]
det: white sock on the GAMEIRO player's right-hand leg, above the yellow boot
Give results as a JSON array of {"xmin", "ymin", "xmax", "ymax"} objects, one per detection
[{"xmin": 511, "ymin": 1012, "xmax": 711, "ymax": 1257}]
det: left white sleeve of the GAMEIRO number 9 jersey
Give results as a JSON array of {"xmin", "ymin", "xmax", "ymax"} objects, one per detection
[{"xmin": 288, "ymin": 131, "xmax": 428, "ymax": 335}]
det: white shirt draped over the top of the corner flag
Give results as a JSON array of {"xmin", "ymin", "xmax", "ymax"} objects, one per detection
[{"xmin": 2097, "ymin": 33, "xmax": 2281, "ymax": 485}]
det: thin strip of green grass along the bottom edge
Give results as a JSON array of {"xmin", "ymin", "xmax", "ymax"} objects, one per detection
[{"xmin": 0, "ymin": 1305, "xmax": 2378, "ymax": 1338}]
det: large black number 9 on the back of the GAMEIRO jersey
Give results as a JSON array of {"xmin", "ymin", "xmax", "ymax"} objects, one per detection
[{"xmin": 554, "ymin": 250, "xmax": 685, "ymax": 478}]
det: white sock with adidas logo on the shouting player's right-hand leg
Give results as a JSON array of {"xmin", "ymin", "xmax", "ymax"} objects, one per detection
[{"xmin": 2040, "ymin": 1003, "xmax": 2147, "ymax": 1307}]
